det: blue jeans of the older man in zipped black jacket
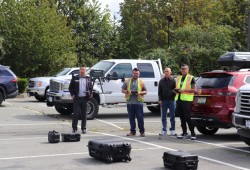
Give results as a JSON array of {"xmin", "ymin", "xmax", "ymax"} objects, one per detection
[{"xmin": 161, "ymin": 100, "xmax": 176, "ymax": 131}]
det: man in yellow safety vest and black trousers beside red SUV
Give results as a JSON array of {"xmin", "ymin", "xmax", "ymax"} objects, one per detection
[{"xmin": 175, "ymin": 64, "xmax": 196, "ymax": 140}]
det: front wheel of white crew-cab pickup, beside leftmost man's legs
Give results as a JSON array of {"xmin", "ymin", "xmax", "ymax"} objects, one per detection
[{"xmin": 87, "ymin": 97, "xmax": 99, "ymax": 120}]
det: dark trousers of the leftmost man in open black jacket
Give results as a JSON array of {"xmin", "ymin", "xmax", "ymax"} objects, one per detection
[{"xmin": 72, "ymin": 97, "xmax": 88, "ymax": 130}]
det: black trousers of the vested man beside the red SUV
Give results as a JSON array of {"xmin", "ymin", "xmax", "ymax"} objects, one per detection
[{"xmin": 175, "ymin": 100, "xmax": 194, "ymax": 133}]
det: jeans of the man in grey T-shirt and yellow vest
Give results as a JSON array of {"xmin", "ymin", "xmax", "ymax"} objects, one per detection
[{"xmin": 127, "ymin": 104, "xmax": 145, "ymax": 133}]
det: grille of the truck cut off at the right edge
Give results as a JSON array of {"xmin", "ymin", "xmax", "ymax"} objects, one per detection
[{"xmin": 239, "ymin": 92, "xmax": 250, "ymax": 115}]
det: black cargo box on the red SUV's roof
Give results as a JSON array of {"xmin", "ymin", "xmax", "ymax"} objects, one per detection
[{"xmin": 217, "ymin": 52, "xmax": 250, "ymax": 68}]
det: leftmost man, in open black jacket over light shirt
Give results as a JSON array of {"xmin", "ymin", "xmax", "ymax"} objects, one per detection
[{"xmin": 69, "ymin": 65, "xmax": 92, "ymax": 134}]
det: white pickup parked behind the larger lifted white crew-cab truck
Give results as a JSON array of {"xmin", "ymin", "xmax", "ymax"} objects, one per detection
[{"xmin": 27, "ymin": 67, "xmax": 79, "ymax": 101}]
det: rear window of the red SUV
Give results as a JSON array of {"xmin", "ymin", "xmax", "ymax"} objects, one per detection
[{"xmin": 196, "ymin": 74, "xmax": 234, "ymax": 89}]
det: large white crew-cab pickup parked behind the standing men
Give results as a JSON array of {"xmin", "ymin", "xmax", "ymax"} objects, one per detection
[{"xmin": 47, "ymin": 59, "xmax": 163, "ymax": 119}]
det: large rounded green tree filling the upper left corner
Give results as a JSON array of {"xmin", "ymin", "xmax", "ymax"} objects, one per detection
[{"xmin": 0, "ymin": 0, "xmax": 76, "ymax": 77}]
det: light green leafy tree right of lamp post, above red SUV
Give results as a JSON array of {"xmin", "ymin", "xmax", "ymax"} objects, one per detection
[{"xmin": 169, "ymin": 25, "xmax": 234, "ymax": 76}]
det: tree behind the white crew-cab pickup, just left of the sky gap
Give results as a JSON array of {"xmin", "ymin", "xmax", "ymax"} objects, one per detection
[{"xmin": 57, "ymin": 0, "xmax": 117, "ymax": 65}]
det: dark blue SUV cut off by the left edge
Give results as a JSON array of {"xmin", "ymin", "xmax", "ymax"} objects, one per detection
[{"xmin": 0, "ymin": 65, "xmax": 18, "ymax": 105}]
